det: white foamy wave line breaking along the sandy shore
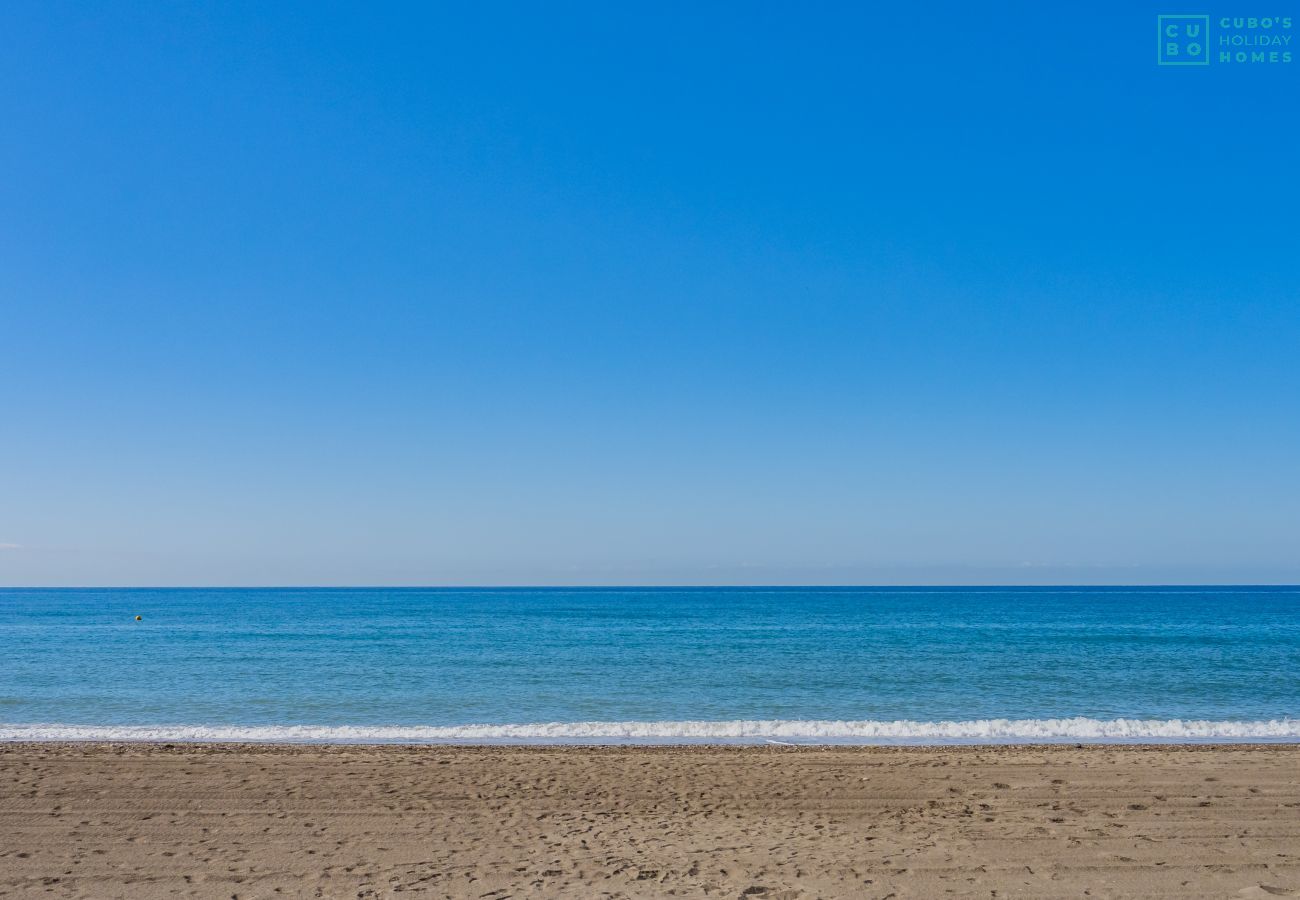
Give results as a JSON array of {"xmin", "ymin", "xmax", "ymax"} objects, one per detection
[{"xmin": 0, "ymin": 717, "xmax": 1300, "ymax": 744}]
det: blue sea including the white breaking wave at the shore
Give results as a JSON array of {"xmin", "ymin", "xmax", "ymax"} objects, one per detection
[{"xmin": 0, "ymin": 588, "xmax": 1300, "ymax": 743}]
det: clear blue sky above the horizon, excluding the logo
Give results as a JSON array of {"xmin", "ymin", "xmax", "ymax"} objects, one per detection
[{"xmin": 0, "ymin": 0, "xmax": 1300, "ymax": 585}]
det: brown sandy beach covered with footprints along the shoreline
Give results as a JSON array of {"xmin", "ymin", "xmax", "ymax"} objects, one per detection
[{"xmin": 0, "ymin": 744, "xmax": 1300, "ymax": 900}]
